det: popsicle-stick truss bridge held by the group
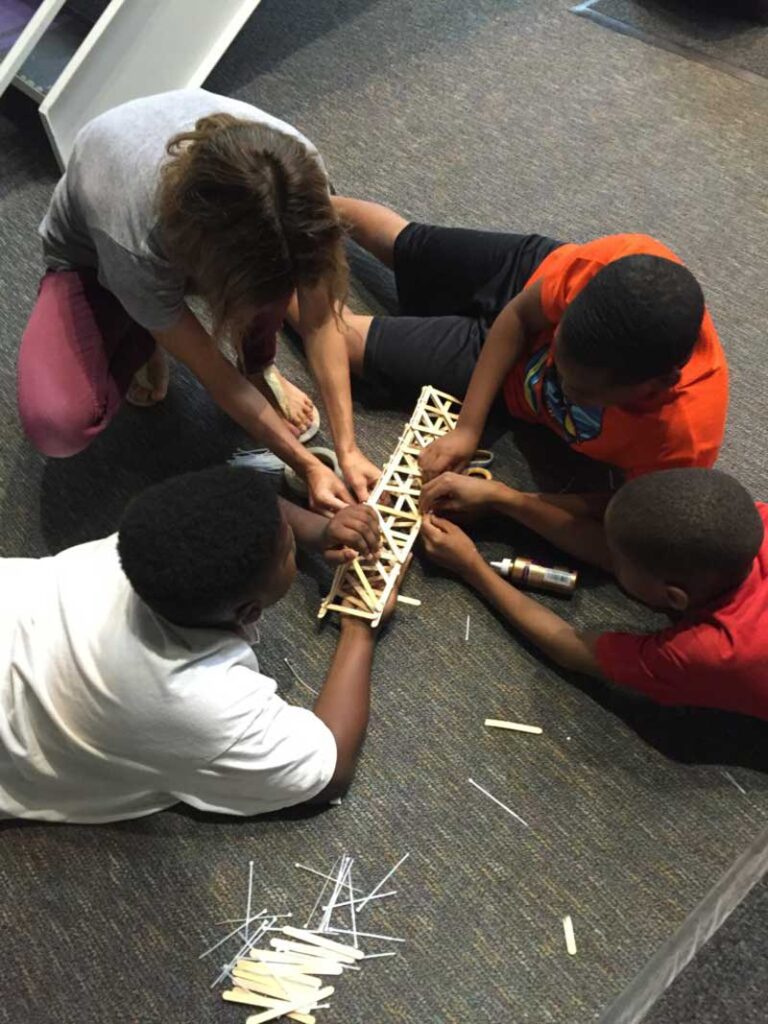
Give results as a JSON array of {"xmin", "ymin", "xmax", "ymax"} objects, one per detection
[{"xmin": 318, "ymin": 385, "xmax": 461, "ymax": 626}]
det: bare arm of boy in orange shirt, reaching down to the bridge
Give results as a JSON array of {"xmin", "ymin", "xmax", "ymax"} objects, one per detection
[{"xmin": 419, "ymin": 282, "xmax": 552, "ymax": 480}]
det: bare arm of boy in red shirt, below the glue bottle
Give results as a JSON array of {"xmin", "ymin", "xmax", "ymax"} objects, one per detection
[{"xmin": 422, "ymin": 516, "xmax": 604, "ymax": 679}]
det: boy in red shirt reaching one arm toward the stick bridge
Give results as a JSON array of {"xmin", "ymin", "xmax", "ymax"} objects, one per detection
[{"xmin": 422, "ymin": 469, "xmax": 768, "ymax": 719}]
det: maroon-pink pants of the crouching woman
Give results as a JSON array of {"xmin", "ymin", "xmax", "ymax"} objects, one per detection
[{"xmin": 17, "ymin": 268, "xmax": 288, "ymax": 458}]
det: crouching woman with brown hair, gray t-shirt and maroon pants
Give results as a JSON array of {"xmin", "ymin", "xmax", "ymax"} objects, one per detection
[{"xmin": 18, "ymin": 89, "xmax": 378, "ymax": 512}]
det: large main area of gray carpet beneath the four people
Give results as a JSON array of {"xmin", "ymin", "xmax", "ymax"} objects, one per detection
[{"xmin": 0, "ymin": 0, "xmax": 768, "ymax": 1024}]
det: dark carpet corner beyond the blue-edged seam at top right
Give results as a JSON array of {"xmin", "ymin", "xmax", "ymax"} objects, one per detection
[{"xmin": 573, "ymin": 0, "xmax": 768, "ymax": 78}]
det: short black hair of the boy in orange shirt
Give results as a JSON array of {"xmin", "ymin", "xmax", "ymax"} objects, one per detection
[{"xmin": 558, "ymin": 255, "xmax": 705, "ymax": 384}]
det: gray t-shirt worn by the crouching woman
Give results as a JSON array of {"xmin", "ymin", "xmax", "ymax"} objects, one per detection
[{"xmin": 40, "ymin": 89, "xmax": 322, "ymax": 331}]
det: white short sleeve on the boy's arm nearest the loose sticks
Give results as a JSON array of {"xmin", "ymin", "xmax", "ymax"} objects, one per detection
[{"xmin": 171, "ymin": 666, "xmax": 336, "ymax": 815}]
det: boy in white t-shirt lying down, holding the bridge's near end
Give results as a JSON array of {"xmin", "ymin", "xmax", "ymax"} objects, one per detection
[{"xmin": 0, "ymin": 466, "xmax": 387, "ymax": 822}]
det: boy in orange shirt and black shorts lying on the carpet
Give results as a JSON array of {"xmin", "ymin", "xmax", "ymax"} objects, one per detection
[{"xmin": 301, "ymin": 197, "xmax": 728, "ymax": 567}]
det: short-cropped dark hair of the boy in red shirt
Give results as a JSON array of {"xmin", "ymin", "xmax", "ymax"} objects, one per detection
[{"xmin": 605, "ymin": 469, "xmax": 764, "ymax": 596}]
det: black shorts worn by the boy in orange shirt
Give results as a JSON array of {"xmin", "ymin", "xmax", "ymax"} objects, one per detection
[{"xmin": 362, "ymin": 223, "xmax": 562, "ymax": 399}]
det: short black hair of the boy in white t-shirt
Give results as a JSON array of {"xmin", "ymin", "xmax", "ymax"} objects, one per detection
[{"xmin": 118, "ymin": 466, "xmax": 282, "ymax": 626}]
